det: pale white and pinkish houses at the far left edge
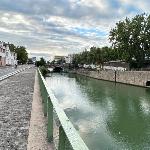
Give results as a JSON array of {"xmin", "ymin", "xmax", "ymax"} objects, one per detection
[{"xmin": 0, "ymin": 41, "xmax": 17, "ymax": 66}]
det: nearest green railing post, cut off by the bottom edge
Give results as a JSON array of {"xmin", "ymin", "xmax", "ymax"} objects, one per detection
[{"xmin": 58, "ymin": 126, "xmax": 66, "ymax": 150}]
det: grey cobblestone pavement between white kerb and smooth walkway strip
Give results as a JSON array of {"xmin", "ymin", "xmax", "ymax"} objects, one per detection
[{"xmin": 0, "ymin": 68, "xmax": 35, "ymax": 150}]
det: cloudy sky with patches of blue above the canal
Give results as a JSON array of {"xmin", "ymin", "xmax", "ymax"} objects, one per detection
[{"xmin": 0, "ymin": 0, "xmax": 150, "ymax": 59}]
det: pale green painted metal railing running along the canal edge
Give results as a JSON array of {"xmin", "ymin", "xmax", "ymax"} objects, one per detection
[{"xmin": 38, "ymin": 69, "xmax": 89, "ymax": 150}]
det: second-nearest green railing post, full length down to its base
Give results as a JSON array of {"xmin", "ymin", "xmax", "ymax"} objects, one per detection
[{"xmin": 47, "ymin": 96, "xmax": 53, "ymax": 142}]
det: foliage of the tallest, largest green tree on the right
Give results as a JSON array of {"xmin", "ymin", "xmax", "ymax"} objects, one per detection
[{"xmin": 110, "ymin": 14, "xmax": 150, "ymax": 67}]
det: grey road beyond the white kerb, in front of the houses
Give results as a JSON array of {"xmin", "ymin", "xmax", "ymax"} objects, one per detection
[{"xmin": 0, "ymin": 65, "xmax": 31, "ymax": 77}]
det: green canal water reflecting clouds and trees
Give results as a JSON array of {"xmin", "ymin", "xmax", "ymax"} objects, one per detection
[{"xmin": 46, "ymin": 74, "xmax": 150, "ymax": 150}]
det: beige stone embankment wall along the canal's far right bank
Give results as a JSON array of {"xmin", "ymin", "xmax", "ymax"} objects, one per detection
[{"xmin": 72, "ymin": 69, "xmax": 150, "ymax": 87}]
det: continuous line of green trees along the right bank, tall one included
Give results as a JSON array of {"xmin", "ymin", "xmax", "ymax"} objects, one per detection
[{"xmin": 73, "ymin": 14, "xmax": 150, "ymax": 68}]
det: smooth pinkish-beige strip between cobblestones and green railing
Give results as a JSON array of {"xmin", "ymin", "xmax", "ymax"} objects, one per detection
[{"xmin": 27, "ymin": 73, "xmax": 53, "ymax": 150}]
